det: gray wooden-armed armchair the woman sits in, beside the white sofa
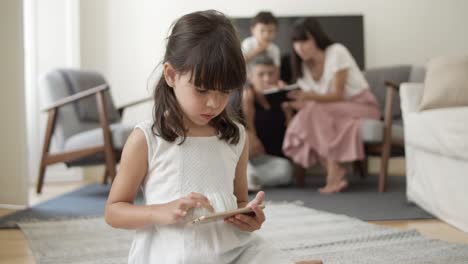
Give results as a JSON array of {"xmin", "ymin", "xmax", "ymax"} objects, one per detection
[{"xmin": 355, "ymin": 65, "xmax": 425, "ymax": 192}]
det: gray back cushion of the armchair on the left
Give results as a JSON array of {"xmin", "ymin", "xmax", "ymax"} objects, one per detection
[{"xmin": 59, "ymin": 69, "xmax": 120, "ymax": 123}]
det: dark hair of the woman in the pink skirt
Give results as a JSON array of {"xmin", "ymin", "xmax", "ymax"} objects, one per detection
[{"xmin": 291, "ymin": 17, "xmax": 334, "ymax": 81}]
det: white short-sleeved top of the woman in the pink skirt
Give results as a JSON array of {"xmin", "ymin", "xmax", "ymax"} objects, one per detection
[{"xmin": 297, "ymin": 43, "xmax": 369, "ymax": 98}]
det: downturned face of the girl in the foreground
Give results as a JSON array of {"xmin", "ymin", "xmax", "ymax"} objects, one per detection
[{"xmin": 165, "ymin": 63, "xmax": 229, "ymax": 128}]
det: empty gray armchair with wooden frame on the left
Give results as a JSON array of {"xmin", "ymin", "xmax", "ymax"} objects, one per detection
[{"xmin": 36, "ymin": 69, "xmax": 151, "ymax": 193}]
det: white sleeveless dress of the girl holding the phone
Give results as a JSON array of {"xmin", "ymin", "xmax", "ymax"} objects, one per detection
[{"xmin": 128, "ymin": 121, "xmax": 292, "ymax": 264}]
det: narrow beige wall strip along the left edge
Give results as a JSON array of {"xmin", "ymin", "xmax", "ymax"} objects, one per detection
[{"xmin": 0, "ymin": 0, "xmax": 28, "ymax": 206}]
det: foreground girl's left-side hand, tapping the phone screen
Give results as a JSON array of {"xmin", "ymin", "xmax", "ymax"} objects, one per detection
[{"xmin": 154, "ymin": 192, "xmax": 214, "ymax": 225}]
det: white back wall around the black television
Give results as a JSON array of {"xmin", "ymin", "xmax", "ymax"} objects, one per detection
[{"xmin": 81, "ymin": 0, "xmax": 468, "ymax": 124}]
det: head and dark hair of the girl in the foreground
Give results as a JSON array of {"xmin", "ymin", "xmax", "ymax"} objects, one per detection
[{"xmin": 153, "ymin": 10, "xmax": 246, "ymax": 143}]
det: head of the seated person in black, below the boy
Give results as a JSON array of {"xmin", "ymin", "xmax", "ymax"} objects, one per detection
[{"xmin": 248, "ymin": 54, "xmax": 278, "ymax": 91}]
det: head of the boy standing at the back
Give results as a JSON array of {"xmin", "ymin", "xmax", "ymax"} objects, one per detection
[{"xmin": 250, "ymin": 11, "xmax": 278, "ymax": 43}]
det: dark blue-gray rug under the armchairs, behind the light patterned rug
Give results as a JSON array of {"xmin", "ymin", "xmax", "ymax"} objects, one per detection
[{"xmin": 0, "ymin": 176, "xmax": 433, "ymax": 228}]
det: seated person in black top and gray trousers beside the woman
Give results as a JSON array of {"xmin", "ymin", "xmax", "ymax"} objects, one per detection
[{"xmin": 242, "ymin": 55, "xmax": 293, "ymax": 190}]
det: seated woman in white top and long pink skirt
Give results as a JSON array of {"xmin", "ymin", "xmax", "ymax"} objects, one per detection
[{"xmin": 283, "ymin": 18, "xmax": 380, "ymax": 193}]
